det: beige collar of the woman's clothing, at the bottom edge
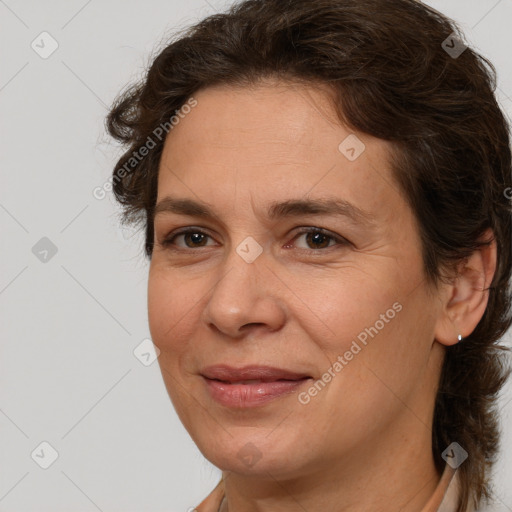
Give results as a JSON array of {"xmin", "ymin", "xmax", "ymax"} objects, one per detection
[{"xmin": 196, "ymin": 464, "xmax": 485, "ymax": 512}]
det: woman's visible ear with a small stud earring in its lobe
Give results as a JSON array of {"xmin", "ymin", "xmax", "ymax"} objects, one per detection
[{"xmin": 435, "ymin": 229, "xmax": 497, "ymax": 345}]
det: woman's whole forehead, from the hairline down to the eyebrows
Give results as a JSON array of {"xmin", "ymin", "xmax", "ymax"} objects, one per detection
[{"xmin": 158, "ymin": 82, "xmax": 406, "ymax": 221}]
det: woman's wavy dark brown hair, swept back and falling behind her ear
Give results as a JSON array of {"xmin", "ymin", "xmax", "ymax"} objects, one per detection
[{"xmin": 107, "ymin": 0, "xmax": 512, "ymax": 511}]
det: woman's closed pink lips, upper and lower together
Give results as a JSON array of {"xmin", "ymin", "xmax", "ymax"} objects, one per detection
[{"xmin": 201, "ymin": 365, "xmax": 312, "ymax": 409}]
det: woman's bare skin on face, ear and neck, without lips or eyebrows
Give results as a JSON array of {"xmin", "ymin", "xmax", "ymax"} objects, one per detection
[{"xmin": 148, "ymin": 82, "xmax": 496, "ymax": 512}]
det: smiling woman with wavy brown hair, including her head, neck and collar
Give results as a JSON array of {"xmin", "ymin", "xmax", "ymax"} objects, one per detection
[{"xmin": 108, "ymin": 0, "xmax": 512, "ymax": 512}]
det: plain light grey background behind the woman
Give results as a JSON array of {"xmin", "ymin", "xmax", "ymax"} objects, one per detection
[{"xmin": 0, "ymin": 0, "xmax": 512, "ymax": 512}]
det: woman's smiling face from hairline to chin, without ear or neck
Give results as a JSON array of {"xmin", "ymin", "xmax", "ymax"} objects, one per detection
[{"xmin": 148, "ymin": 83, "xmax": 444, "ymax": 477}]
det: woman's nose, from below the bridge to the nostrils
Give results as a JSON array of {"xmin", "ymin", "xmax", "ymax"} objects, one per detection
[{"xmin": 202, "ymin": 250, "xmax": 286, "ymax": 339}]
